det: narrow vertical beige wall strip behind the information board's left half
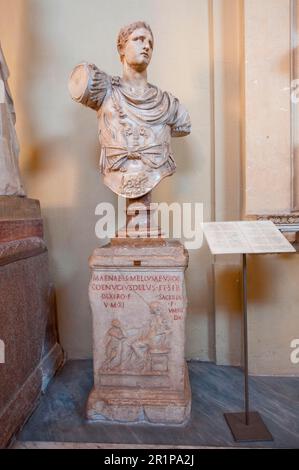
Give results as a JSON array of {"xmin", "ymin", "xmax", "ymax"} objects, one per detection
[{"xmin": 211, "ymin": 0, "xmax": 243, "ymax": 365}]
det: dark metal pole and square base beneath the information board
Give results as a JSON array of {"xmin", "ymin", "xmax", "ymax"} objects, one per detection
[{"xmin": 224, "ymin": 253, "xmax": 273, "ymax": 442}]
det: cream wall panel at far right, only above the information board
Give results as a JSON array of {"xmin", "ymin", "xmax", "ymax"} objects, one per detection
[{"xmin": 244, "ymin": 0, "xmax": 292, "ymax": 215}]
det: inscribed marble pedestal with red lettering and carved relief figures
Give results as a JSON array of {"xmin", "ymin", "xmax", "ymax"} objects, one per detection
[{"xmin": 87, "ymin": 239, "xmax": 191, "ymax": 424}]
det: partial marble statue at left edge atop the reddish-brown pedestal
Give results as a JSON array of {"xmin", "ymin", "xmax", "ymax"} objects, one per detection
[{"xmin": 0, "ymin": 40, "xmax": 25, "ymax": 196}]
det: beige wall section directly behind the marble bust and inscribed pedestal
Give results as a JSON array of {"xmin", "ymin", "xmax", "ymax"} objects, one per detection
[{"xmin": 0, "ymin": 0, "xmax": 214, "ymax": 360}]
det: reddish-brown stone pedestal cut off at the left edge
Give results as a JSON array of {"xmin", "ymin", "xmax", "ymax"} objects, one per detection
[{"xmin": 0, "ymin": 196, "xmax": 64, "ymax": 448}]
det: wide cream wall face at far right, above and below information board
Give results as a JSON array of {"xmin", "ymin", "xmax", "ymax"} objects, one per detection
[{"xmin": 242, "ymin": 0, "xmax": 299, "ymax": 375}]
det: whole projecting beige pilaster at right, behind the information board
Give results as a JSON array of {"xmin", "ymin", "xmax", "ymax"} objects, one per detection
[{"xmin": 213, "ymin": 0, "xmax": 299, "ymax": 375}]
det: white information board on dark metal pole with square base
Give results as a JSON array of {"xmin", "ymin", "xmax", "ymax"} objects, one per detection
[{"xmin": 202, "ymin": 220, "xmax": 296, "ymax": 442}]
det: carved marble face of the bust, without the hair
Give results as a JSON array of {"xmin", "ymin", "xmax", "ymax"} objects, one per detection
[{"xmin": 123, "ymin": 28, "xmax": 153, "ymax": 70}]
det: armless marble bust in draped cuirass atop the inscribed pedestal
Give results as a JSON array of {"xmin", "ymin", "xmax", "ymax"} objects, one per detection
[{"xmin": 69, "ymin": 21, "xmax": 191, "ymax": 199}]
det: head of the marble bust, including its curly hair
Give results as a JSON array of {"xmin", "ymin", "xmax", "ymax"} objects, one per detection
[{"xmin": 117, "ymin": 21, "xmax": 154, "ymax": 71}]
